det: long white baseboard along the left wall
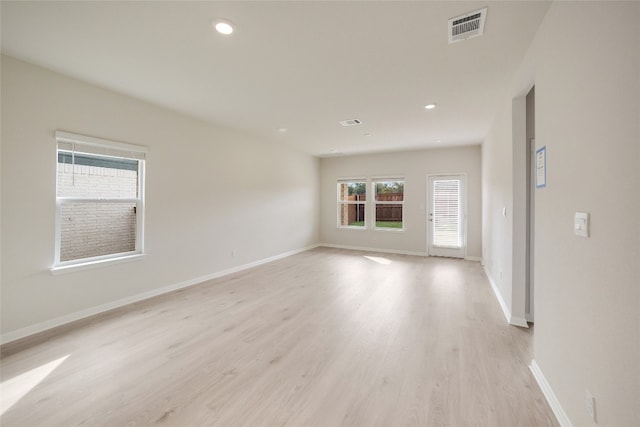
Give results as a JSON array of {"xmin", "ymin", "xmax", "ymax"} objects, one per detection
[{"xmin": 0, "ymin": 245, "xmax": 319, "ymax": 345}]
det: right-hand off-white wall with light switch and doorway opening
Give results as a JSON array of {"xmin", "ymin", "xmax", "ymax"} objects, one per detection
[{"xmin": 483, "ymin": 2, "xmax": 640, "ymax": 426}]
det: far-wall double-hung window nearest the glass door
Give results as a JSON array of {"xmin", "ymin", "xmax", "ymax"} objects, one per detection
[{"xmin": 373, "ymin": 178, "xmax": 404, "ymax": 230}]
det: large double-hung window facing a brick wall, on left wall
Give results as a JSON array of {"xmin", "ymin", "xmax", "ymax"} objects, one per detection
[{"xmin": 54, "ymin": 132, "xmax": 146, "ymax": 270}]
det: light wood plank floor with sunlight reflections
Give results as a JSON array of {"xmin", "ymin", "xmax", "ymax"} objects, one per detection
[{"xmin": 0, "ymin": 248, "xmax": 557, "ymax": 427}]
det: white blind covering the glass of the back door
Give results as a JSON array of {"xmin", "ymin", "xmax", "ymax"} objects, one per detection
[{"xmin": 433, "ymin": 179, "xmax": 462, "ymax": 248}]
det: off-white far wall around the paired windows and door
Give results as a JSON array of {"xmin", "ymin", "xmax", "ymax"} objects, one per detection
[{"xmin": 320, "ymin": 146, "xmax": 482, "ymax": 259}]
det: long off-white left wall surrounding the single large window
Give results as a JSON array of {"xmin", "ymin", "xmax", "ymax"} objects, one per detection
[{"xmin": 1, "ymin": 56, "xmax": 319, "ymax": 340}]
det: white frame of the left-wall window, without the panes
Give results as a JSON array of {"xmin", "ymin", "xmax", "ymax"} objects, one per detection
[{"xmin": 51, "ymin": 131, "xmax": 148, "ymax": 273}]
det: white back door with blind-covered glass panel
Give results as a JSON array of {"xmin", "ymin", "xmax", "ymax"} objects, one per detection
[{"xmin": 427, "ymin": 175, "xmax": 466, "ymax": 258}]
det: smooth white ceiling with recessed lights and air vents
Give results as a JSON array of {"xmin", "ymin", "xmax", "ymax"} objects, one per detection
[{"xmin": 1, "ymin": 1, "xmax": 549, "ymax": 156}]
